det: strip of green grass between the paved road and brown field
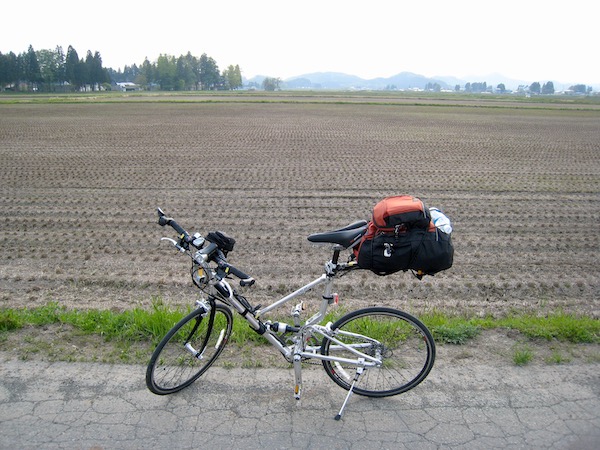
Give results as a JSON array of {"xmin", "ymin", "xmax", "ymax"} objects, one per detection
[{"xmin": 0, "ymin": 299, "xmax": 600, "ymax": 345}]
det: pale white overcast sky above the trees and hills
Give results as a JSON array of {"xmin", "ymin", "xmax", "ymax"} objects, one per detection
[{"xmin": 0, "ymin": 0, "xmax": 600, "ymax": 85}]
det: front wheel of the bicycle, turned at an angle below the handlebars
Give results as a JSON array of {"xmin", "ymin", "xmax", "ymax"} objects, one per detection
[{"xmin": 146, "ymin": 303, "xmax": 233, "ymax": 395}]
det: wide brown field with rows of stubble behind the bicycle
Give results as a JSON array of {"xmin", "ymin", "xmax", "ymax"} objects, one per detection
[{"xmin": 0, "ymin": 93, "xmax": 600, "ymax": 317}]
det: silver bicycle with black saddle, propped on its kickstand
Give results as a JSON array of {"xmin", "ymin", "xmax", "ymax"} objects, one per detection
[{"xmin": 146, "ymin": 208, "xmax": 435, "ymax": 420}]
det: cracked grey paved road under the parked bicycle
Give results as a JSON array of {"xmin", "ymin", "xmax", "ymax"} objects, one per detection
[{"xmin": 0, "ymin": 354, "xmax": 600, "ymax": 450}]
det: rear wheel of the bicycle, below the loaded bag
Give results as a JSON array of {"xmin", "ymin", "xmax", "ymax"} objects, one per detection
[{"xmin": 321, "ymin": 307, "xmax": 435, "ymax": 397}]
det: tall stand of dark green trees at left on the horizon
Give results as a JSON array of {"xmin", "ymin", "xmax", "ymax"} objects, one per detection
[{"xmin": 0, "ymin": 45, "xmax": 242, "ymax": 92}]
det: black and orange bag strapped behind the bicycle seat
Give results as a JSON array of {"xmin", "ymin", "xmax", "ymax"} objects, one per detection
[{"xmin": 356, "ymin": 196, "xmax": 454, "ymax": 278}]
